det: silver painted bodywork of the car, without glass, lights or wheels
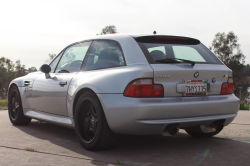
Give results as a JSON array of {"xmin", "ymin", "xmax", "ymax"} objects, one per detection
[{"xmin": 10, "ymin": 34, "xmax": 239, "ymax": 135}]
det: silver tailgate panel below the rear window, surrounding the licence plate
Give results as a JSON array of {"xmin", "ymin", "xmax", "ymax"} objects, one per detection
[{"xmin": 150, "ymin": 64, "xmax": 230, "ymax": 97}]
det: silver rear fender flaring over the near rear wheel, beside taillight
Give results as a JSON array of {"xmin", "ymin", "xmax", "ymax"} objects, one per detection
[{"xmin": 67, "ymin": 64, "xmax": 153, "ymax": 118}]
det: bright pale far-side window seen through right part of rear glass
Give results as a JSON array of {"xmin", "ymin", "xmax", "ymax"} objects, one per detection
[{"xmin": 173, "ymin": 46, "xmax": 206, "ymax": 62}]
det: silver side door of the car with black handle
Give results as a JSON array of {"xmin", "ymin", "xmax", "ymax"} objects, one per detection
[{"xmin": 31, "ymin": 73, "xmax": 76, "ymax": 116}]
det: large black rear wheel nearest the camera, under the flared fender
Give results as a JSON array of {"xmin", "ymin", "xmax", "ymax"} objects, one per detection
[{"xmin": 74, "ymin": 92, "xmax": 117, "ymax": 150}]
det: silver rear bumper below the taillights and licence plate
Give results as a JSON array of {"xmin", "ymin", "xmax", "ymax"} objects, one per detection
[{"xmin": 97, "ymin": 94, "xmax": 239, "ymax": 135}]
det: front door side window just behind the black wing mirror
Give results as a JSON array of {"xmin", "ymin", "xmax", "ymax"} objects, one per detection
[{"xmin": 56, "ymin": 42, "xmax": 91, "ymax": 73}]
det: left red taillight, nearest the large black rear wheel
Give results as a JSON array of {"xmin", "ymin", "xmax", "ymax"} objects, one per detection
[{"xmin": 123, "ymin": 78, "xmax": 164, "ymax": 97}]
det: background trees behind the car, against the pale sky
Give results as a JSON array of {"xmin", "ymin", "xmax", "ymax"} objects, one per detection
[{"xmin": 0, "ymin": 25, "xmax": 250, "ymax": 101}]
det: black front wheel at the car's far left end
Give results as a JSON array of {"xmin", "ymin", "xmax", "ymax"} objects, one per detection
[{"xmin": 8, "ymin": 86, "xmax": 31, "ymax": 125}]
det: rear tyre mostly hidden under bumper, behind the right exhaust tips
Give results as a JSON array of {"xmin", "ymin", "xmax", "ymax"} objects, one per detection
[{"xmin": 185, "ymin": 126, "xmax": 223, "ymax": 138}]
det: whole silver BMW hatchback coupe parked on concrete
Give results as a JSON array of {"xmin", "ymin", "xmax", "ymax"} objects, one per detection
[{"xmin": 8, "ymin": 34, "xmax": 239, "ymax": 150}]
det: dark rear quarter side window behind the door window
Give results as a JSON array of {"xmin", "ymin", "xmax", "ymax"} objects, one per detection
[{"xmin": 84, "ymin": 41, "xmax": 125, "ymax": 70}]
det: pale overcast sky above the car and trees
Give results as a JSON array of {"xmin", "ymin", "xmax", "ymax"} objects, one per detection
[{"xmin": 0, "ymin": 0, "xmax": 250, "ymax": 68}]
